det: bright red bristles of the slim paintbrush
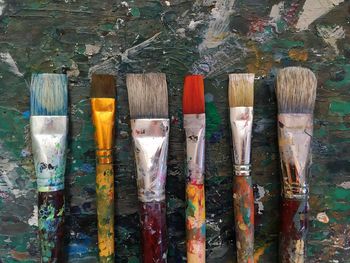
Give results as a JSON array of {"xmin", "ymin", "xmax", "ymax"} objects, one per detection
[{"xmin": 182, "ymin": 75, "xmax": 205, "ymax": 114}]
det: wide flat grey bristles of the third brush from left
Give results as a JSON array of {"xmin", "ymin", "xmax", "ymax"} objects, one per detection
[{"xmin": 126, "ymin": 73, "xmax": 168, "ymax": 119}]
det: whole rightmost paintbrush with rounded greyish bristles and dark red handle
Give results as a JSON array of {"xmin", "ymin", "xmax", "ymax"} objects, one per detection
[{"xmin": 276, "ymin": 67, "xmax": 317, "ymax": 263}]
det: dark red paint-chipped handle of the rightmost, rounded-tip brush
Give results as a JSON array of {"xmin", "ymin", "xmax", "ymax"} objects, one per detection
[{"xmin": 279, "ymin": 197, "xmax": 308, "ymax": 263}]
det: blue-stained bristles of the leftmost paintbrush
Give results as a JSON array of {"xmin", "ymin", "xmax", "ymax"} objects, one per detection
[{"xmin": 30, "ymin": 73, "xmax": 68, "ymax": 116}]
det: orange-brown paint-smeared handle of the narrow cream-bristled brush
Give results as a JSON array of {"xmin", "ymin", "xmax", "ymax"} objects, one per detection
[{"xmin": 233, "ymin": 176, "xmax": 254, "ymax": 263}]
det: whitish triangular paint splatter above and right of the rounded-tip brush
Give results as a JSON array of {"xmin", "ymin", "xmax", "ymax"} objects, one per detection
[{"xmin": 316, "ymin": 25, "xmax": 345, "ymax": 55}]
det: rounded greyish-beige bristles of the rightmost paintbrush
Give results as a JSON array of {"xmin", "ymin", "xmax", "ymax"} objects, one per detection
[{"xmin": 276, "ymin": 67, "xmax": 317, "ymax": 113}]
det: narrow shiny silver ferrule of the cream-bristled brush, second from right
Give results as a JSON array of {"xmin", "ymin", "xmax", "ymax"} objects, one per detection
[{"xmin": 230, "ymin": 107, "xmax": 253, "ymax": 176}]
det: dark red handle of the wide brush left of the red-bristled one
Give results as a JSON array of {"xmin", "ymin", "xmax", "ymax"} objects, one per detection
[{"xmin": 140, "ymin": 200, "xmax": 168, "ymax": 263}]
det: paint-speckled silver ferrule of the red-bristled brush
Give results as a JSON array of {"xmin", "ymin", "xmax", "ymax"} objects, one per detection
[{"xmin": 184, "ymin": 113, "xmax": 205, "ymax": 184}]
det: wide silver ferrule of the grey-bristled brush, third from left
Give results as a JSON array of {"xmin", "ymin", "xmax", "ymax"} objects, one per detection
[{"xmin": 131, "ymin": 119, "xmax": 169, "ymax": 202}]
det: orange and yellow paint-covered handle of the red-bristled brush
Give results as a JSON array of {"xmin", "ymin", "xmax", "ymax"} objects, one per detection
[{"xmin": 186, "ymin": 183, "xmax": 205, "ymax": 263}]
